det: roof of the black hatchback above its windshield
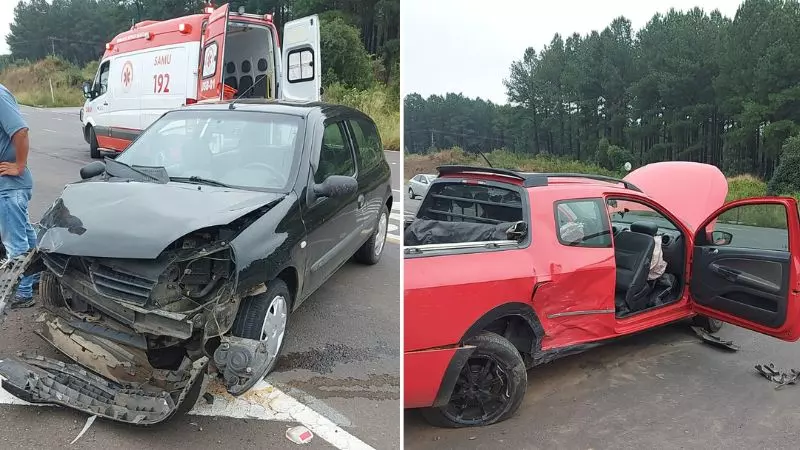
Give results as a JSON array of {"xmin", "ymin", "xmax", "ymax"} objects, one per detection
[{"xmin": 180, "ymin": 98, "xmax": 372, "ymax": 120}]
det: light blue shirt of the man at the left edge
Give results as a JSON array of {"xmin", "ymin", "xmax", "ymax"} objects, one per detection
[{"xmin": 0, "ymin": 84, "xmax": 33, "ymax": 191}]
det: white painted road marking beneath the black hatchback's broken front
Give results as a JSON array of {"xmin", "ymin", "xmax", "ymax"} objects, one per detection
[{"xmin": 0, "ymin": 377, "xmax": 374, "ymax": 450}]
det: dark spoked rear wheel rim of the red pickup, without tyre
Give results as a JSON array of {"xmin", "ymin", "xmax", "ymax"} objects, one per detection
[{"xmin": 445, "ymin": 355, "xmax": 511, "ymax": 424}]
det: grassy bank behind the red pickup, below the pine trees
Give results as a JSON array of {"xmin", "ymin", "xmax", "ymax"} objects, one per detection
[{"xmin": 412, "ymin": 148, "xmax": 800, "ymax": 230}]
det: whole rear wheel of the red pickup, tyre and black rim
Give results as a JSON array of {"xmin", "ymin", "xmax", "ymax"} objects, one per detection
[{"xmin": 422, "ymin": 331, "xmax": 528, "ymax": 428}]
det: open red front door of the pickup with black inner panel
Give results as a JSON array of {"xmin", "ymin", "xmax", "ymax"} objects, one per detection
[{"xmin": 689, "ymin": 197, "xmax": 800, "ymax": 341}]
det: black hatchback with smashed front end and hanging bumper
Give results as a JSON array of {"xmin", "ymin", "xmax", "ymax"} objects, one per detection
[{"xmin": 0, "ymin": 100, "xmax": 392, "ymax": 424}]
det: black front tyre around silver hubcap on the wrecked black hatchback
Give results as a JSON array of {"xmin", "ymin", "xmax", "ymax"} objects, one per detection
[{"xmin": 231, "ymin": 278, "xmax": 294, "ymax": 375}]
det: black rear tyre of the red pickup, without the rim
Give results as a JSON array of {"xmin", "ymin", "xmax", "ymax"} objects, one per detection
[{"xmin": 421, "ymin": 331, "xmax": 528, "ymax": 428}]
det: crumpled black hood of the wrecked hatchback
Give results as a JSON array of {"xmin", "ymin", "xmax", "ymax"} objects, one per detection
[{"xmin": 39, "ymin": 181, "xmax": 283, "ymax": 259}]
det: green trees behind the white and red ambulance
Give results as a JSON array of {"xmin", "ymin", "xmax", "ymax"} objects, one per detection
[{"xmin": 6, "ymin": 0, "xmax": 400, "ymax": 87}]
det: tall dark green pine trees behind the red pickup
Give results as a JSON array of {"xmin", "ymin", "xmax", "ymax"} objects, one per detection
[{"xmin": 404, "ymin": 0, "xmax": 800, "ymax": 178}]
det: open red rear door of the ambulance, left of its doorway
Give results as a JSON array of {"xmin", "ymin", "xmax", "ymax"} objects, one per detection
[{"xmin": 197, "ymin": 4, "xmax": 230, "ymax": 100}]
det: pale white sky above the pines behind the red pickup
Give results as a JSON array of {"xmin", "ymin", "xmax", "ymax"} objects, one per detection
[{"xmin": 400, "ymin": 0, "xmax": 741, "ymax": 104}]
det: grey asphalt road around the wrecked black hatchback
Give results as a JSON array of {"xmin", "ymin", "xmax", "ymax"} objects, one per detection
[{"xmin": 0, "ymin": 108, "xmax": 400, "ymax": 450}]
